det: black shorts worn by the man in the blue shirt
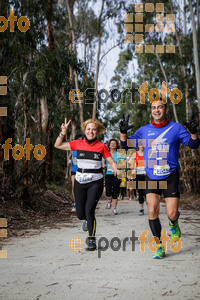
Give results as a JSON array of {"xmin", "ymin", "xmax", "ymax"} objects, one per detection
[{"xmin": 146, "ymin": 168, "xmax": 180, "ymax": 198}]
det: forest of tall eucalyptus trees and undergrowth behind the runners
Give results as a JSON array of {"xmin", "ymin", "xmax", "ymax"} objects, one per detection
[{"xmin": 0, "ymin": 0, "xmax": 200, "ymax": 232}]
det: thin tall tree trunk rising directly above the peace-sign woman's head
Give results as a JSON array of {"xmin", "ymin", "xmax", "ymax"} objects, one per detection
[{"xmin": 92, "ymin": 0, "xmax": 105, "ymax": 119}]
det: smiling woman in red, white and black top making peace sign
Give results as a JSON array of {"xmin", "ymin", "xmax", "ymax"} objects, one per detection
[{"xmin": 54, "ymin": 118, "xmax": 117, "ymax": 251}]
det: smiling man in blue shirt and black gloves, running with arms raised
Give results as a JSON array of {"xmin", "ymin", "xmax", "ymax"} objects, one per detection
[{"xmin": 120, "ymin": 100, "xmax": 199, "ymax": 258}]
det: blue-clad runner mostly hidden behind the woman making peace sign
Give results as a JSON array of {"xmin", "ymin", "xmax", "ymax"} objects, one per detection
[{"xmin": 67, "ymin": 133, "xmax": 84, "ymax": 212}]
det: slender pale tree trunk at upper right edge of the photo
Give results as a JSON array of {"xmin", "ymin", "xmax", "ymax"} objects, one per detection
[{"xmin": 188, "ymin": 0, "xmax": 200, "ymax": 126}]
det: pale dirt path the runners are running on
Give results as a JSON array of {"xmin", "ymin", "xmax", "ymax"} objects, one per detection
[{"xmin": 0, "ymin": 200, "xmax": 200, "ymax": 300}]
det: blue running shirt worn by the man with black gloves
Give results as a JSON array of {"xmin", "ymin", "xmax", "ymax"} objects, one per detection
[{"xmin": 126, "ymin": 121, "xmax": 190, "ymax": 180}]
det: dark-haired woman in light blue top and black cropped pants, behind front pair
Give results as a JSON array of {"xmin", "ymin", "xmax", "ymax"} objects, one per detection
[{"xmin": 105, "ymin": 139, "xmax": 121, "ymax": 215}]
